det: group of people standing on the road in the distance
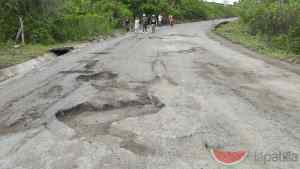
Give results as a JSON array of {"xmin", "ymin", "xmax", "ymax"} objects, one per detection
[{"xmin": 125, "ymin": 14, "xmax": 175, "ymax": 33}]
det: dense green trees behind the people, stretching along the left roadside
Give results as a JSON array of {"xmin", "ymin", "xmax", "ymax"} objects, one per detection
[{"xmin": 0, "ymin": 0, "xmax": 235, "ymax": 44}]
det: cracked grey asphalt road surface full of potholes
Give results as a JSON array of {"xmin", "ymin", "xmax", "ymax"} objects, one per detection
[{"xmin": 0, "ymin": 21, "xmax": 300, "ymax": 169}]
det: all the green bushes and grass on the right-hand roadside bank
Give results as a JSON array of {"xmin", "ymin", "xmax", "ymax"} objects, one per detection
[{"xmin": 217, "ymin": 0, "xmax": 300, "ymax": 60}]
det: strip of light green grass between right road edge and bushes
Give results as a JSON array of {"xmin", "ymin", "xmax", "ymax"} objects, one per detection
[{"xmin": 215, "ymin": 21, "xmax": 295, "ymax": 59}]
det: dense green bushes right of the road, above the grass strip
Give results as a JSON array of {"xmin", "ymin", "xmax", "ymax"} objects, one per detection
[{"xmin": 240, "ymin": 0, "xmax": 300, "ymax": 54}]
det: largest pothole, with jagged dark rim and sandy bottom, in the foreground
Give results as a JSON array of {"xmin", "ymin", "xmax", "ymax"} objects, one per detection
[{"xmin": 56, "ymin": 80, "xmax": 165, "ymax": 156}]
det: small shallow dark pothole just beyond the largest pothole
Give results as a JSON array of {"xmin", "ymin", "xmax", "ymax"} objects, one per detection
[{"xmin": 77, "ymin": 71, "xmax": 118, "ymax": 82}]
